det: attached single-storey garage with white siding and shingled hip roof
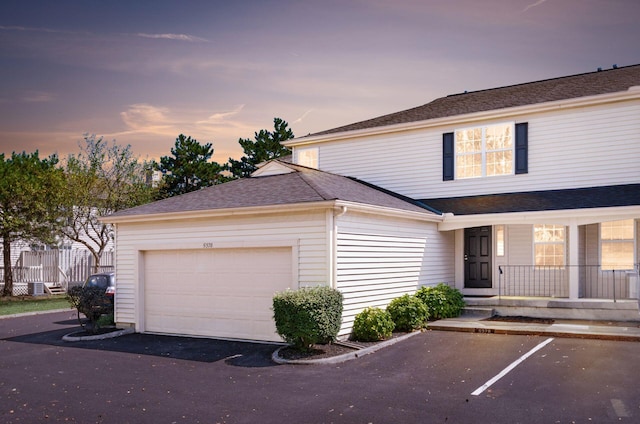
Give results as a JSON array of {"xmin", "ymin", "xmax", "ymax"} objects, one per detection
[{"xmin": 103, "ymin": 161, "xmax": 440, "ymax": 341}]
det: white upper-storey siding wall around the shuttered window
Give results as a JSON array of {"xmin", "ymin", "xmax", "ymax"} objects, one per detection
[{"xmin": 304, "ymin": 100, "xmax": 640, "ymax": 199}]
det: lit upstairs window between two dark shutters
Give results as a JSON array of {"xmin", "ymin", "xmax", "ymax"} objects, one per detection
[{"xmin": 455, "ymin": 124, "xmax": 514, "ymax": 179}]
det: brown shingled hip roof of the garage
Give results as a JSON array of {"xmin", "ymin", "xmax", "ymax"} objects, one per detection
[{"xmin": 109, "ymin": 160, "xmax": 435, "ymax": 217}]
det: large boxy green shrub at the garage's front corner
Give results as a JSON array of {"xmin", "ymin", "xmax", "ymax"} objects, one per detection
[{"xmin": 273, "ymin": 286, "xmax": 342, "ymax": 351}]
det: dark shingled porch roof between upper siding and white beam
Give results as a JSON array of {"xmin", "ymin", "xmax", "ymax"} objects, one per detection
[{"xmin": 421, "ymin": 184, "xmax": 640, "ymax": 215}]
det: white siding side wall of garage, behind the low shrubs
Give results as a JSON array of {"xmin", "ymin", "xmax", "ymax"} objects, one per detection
[{"xmin": 336, "ymin": 213, "xmax": 454, "ymax": 336}]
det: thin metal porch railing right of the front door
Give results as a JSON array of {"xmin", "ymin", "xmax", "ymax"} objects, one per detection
[{"xmin": 498, "ymin": 264, "xmax": 639, "ymax": 301}]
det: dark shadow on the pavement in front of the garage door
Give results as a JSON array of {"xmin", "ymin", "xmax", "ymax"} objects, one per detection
[{"xmin": 2, "ymin": 328, "xmax": 279, "ymax": 367}]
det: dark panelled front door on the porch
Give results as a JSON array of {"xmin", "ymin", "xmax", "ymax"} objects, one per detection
[{"xmin": 464, "ymin": 227, "xmax": 491, "ymax": 289}]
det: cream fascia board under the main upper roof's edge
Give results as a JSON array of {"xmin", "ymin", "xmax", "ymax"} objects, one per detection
[{"xmin": 281, "ymin": 87, "xmax": 640, "ymax": 147}]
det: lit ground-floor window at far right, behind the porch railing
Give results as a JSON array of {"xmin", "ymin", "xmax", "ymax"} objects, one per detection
[{"xmin": 600, "ymin": 219, "xmax": 635, "ymax": 270}]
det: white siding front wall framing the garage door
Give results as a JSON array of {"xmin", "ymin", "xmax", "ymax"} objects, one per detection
[{"xmin": 116, "ymin": 212, "xmax": 329, "ymax": 324}]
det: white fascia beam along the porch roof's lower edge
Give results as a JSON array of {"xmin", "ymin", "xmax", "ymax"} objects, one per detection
[{"xmin": 438, "ymin": 206, "xmax": 640, "ymax": 231}]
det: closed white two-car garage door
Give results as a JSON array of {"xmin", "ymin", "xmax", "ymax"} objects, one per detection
[{"xmin": 143, "ymin": 247, "xmax": 293, "ymax": 341}]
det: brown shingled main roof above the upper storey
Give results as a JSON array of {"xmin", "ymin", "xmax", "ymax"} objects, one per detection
[{"xmin": 309, "ymin": 65, "xmax": 640, "ymax": 136}]
